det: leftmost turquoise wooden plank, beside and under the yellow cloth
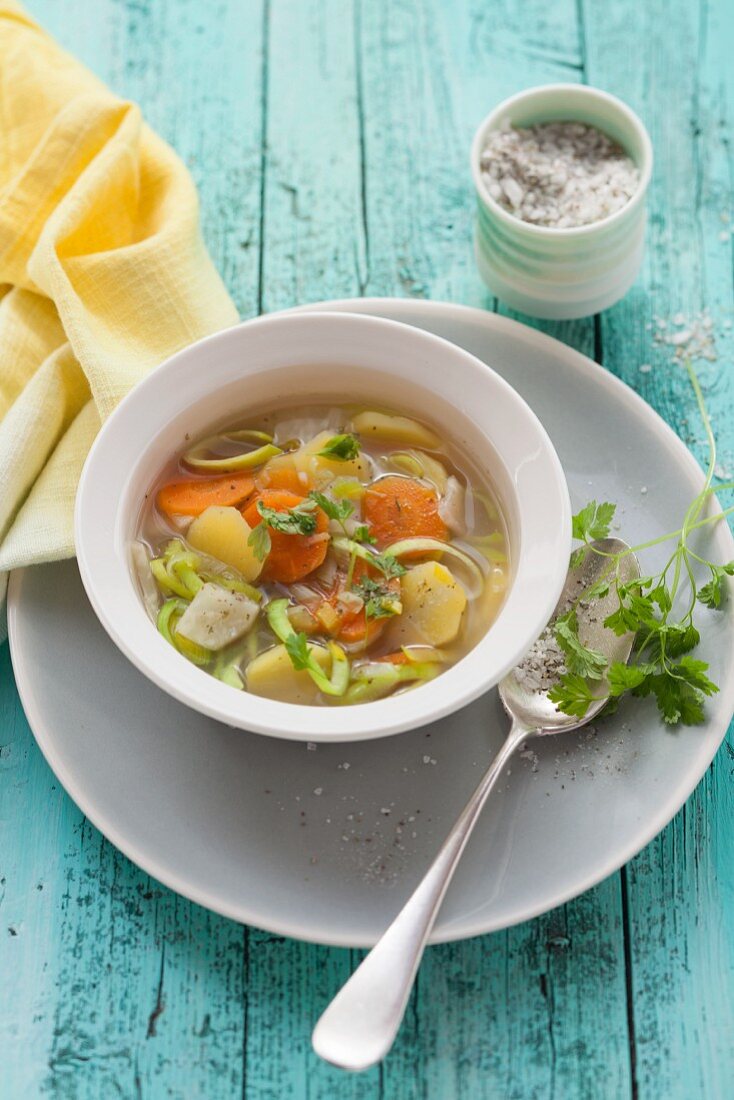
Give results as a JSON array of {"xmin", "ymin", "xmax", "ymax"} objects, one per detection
[{"xmin": 0, "ymin": 0, "xmax": 267, "ymax": 1100}]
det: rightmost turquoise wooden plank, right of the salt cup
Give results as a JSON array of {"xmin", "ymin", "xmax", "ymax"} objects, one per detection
[{"xmin": 584, "ymin": 0, "xmax": 734, "ymax": 1100}]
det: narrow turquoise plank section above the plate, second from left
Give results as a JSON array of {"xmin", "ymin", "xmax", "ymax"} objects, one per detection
[{"xmin": 262, "ymin": 0, "xmax": 366, "ymax": 312}]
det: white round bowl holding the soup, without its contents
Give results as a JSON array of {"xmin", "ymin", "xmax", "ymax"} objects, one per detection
[{"xmin": 75, "ymin": 314, "xmax": 571, "ymax": 741}]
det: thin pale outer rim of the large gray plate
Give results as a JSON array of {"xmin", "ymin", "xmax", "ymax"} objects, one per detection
[{"xmin": 8, "ymin": 297, "xmax": 734, "ymax": 947}]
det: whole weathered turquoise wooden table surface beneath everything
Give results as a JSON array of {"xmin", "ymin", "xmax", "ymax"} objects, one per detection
[{"xmin": 0, "ymin": 0, "xmax": 734, "ymax": 1100}]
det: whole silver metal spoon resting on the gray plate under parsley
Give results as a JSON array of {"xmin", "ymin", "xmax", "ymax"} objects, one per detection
[{"xmin": 313, "ymin": 539, "xmax": 639, "ymax": 1070}]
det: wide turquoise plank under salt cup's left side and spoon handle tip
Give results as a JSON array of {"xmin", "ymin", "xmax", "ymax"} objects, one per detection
[{"xmin": 360, "ymin": 2, "xmax": 629, "ymax": 1100}]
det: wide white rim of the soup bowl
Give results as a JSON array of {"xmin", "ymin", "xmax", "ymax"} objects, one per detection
[{"xmin": 75, "ymin": 310, "xmax": 571, "ymax": 741}]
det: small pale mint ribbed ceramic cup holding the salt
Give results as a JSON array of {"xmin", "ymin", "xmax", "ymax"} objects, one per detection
[{"xmin": 471, "ymin": 84, "xmax": 653, "ymax": 320}]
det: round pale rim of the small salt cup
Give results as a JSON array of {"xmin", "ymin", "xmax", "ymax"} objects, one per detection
[{"xmin": 470, "ymin": 81, "xmax": 653, "ymax": 241}]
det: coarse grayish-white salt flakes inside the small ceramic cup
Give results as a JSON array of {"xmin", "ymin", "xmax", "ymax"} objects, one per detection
[{"xmin": 481, "ymin": 122, "xmax": 639, "ymax": 229}]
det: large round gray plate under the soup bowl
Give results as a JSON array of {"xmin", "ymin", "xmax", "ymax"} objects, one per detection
[{"xmin": 9, "ymin": 299, "xmax": 734, "ymax": 946}]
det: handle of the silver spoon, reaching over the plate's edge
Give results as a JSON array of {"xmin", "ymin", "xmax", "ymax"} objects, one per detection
[{"xmin": 313, "ymin": 719, "xmax": 536, "ymax": 1070}]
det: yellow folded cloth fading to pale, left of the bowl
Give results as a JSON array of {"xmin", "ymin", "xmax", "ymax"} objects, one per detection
[{"xmin": 0, "ymin": 0, "xmax": 237, "ymax": 638}]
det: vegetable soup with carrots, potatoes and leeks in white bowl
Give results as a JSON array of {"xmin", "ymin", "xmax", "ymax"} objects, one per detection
[{"xmin": 132, "ymin": 405, "xmax": 510, "ymax": 705}]
